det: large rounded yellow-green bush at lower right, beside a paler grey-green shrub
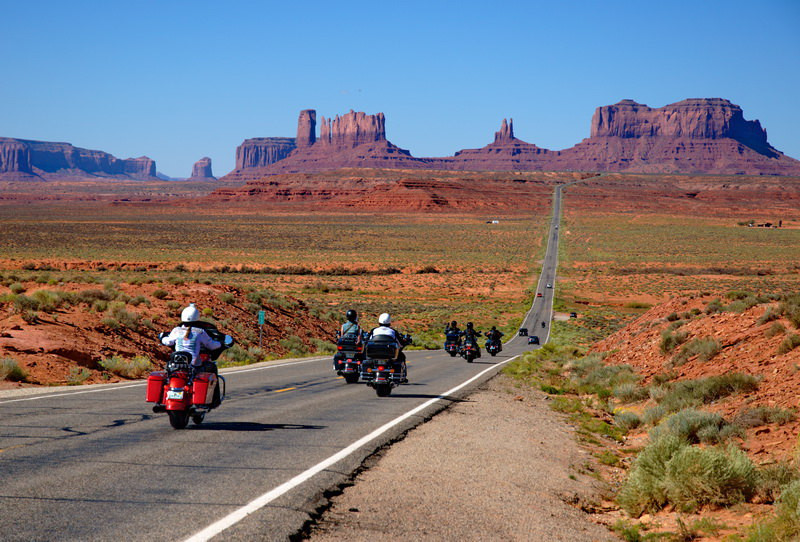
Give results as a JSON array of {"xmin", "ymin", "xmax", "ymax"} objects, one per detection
[{"xmin": 664, "ymin": 446, "xmax": 757, "ymax": 512}]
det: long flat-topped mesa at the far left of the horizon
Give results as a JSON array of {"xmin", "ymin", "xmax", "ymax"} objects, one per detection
[{"xmin": 0, "ymin": 138, "xmax": 156, "ymax": 180}]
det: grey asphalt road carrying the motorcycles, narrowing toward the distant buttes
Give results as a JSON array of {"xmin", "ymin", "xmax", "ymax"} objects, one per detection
[{"xmin": 0, "ymin": 186, "xmax": 561, "ymax": 542}]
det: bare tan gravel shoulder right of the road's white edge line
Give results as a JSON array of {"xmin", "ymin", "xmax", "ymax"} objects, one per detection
[{"xmin": 308, "ymin": 376, "xmax": 618, "ymax": 542}]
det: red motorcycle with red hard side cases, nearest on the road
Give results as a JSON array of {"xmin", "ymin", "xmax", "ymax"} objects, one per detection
[{"xmin": 146, "ymin": 322, "xmax": 234, "ymax": 429}]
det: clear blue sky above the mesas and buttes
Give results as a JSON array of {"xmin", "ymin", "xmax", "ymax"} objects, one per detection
[{"xmin": 0, "ymin": 0, "xmax": 800, "ymax": 177}]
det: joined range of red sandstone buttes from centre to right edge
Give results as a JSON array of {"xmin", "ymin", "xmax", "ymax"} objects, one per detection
[{"xmin": 223, "ymin": 98, "xmax": 800, "ymax": 181}]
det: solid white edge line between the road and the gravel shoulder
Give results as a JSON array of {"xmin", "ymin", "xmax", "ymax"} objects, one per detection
[{"xmin": 185, "ymin": 354, "xmax": 521, "ymax": 542}]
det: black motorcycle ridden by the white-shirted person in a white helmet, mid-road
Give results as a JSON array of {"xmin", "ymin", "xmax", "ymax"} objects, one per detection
[{"xmin": 361, "ymin": 334, "xmax": 413, "ymax": 397}]
